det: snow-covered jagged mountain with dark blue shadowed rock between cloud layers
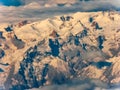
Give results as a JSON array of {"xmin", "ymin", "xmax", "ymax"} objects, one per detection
[{"xmin": 1, "ymin": 12, "xmax": 120, "ymax": 89}]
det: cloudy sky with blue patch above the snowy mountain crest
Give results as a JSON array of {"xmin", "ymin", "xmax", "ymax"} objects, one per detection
[{"xmin": 0, "ymin": 0, "xmax": 120, "ymax": 23}]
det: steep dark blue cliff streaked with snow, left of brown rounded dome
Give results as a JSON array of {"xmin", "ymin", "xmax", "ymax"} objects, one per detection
[{"xmin": 14, "ymin": 41, "xmax": 48, "ymax": 89}]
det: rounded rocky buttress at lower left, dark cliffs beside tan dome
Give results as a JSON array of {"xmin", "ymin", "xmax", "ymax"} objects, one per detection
[{"xmin": 9, "ymin": 41, "xmax": 71, "ymax": 89}]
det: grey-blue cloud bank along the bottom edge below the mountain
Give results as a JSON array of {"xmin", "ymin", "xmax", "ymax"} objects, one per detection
[{"xmin": 29, "ymin": 80, "xmax": 120, "ymax": 90}]
